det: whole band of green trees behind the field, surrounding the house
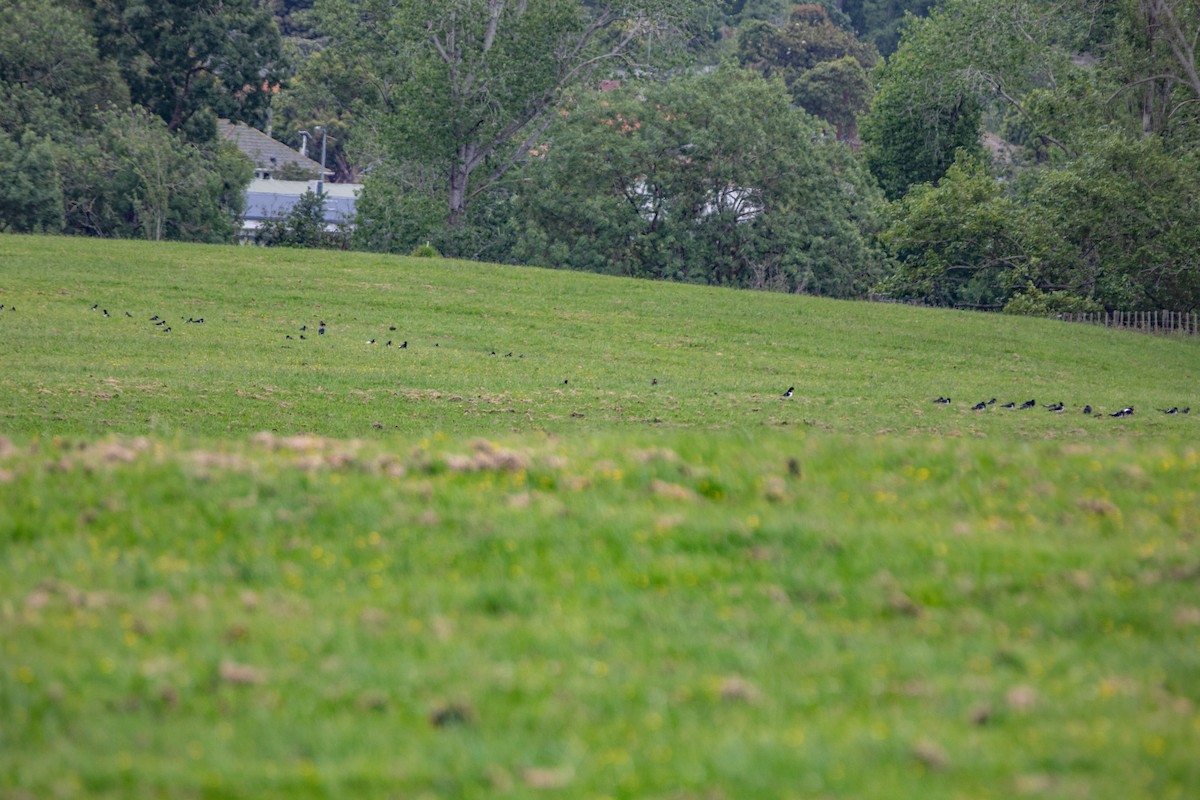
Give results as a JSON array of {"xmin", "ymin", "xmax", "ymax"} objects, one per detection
[{"xmin": 0, "ymin": 0, "xmax": 1200, "ymax": 313}]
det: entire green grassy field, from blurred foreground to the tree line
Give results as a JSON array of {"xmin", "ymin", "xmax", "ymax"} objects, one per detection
[{"xmin": 0, "ymin": 236, "xmax": 1200, "ymax": 800}]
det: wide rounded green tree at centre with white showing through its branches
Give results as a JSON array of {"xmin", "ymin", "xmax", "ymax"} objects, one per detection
[{"xmin": 516, "ymin": 68, "xmax": 882, "ymax": 296}]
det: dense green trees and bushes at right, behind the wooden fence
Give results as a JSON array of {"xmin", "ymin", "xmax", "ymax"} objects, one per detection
[{"xmin": 863, "ymin": 0, "xmax": 1200, "ymax": 313}]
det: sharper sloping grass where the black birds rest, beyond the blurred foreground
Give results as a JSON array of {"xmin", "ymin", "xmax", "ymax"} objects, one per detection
[{"xmin": 0, "ymin": 236, "xmax": 1200, "ymax": 439}]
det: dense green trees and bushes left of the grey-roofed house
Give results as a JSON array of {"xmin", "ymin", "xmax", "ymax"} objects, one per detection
[{"xmin": 0, "ymin": 0, "xmax": 280, "ymax": 242}]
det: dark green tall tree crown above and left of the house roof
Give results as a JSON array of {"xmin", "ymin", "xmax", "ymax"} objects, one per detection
[{"xmin": 86, "ymin": 0, "xmax": 283, "ymax": 138}]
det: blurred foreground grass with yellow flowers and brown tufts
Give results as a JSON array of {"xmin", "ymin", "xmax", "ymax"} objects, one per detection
[{"xmin": 0, "ymin": 429, "xmax": 1200, "ymax": 800}]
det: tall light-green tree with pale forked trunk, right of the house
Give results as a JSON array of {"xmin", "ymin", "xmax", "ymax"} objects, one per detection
[{"xmin": 317, "ymin": 0, "xmax": 689, "ymax": 227}]
